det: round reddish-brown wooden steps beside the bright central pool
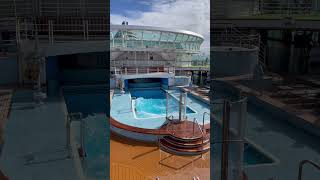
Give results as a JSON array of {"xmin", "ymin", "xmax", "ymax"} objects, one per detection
[{"xmin": 159, "ymin": 121, "xmax": 210, "ymax": 156}]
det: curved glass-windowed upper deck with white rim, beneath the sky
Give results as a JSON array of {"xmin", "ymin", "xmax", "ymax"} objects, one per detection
[{"xmin": 110, "ymin": 25, "xmax": 204, "ymax": 53}]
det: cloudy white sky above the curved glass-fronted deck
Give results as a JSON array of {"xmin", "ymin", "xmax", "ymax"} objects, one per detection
[{"xmin": 110, "ymin": 0, "xmax": 210, "ymax": 53}]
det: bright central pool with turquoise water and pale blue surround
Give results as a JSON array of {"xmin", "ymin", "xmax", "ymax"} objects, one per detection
[{"xmin": 110, "ymin": 88, "xmax": 210, "ymax": 129}]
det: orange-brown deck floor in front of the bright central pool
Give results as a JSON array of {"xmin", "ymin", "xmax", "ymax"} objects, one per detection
[{"xmin": 110, "ymin": 133, "xmax": 210, "ymax": 180}]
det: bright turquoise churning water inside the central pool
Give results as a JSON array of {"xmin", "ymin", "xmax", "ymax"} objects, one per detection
[{"xmin": 130, "ymin": 89, "xmax": 195, "ymax": 118}]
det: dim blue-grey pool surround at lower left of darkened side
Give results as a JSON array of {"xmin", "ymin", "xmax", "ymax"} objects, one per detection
[{"xmin": 0, "ymin": 90, "xmax": 78, "ymax": 180}]
